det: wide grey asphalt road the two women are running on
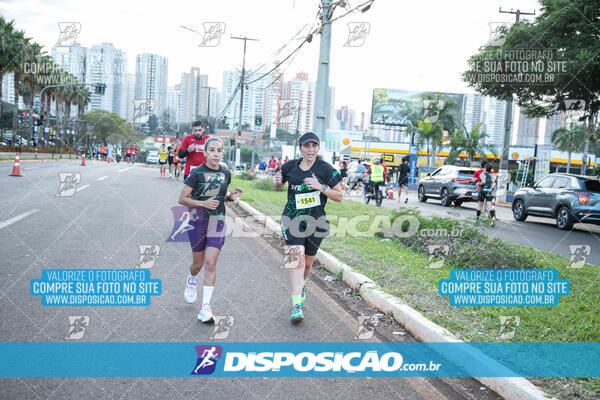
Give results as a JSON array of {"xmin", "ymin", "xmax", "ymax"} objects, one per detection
[{"xmin": 0, "ymin": 161, "xmax": 499, "ymax": 400}]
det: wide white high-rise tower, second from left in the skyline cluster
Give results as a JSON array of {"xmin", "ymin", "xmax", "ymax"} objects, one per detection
[{"xmin": 85, "ymin": 43, "xmax": 127, "ymax": 116}]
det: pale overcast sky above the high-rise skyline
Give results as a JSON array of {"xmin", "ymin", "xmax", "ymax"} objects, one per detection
[{"xmin": 0, "ymin": 0, "xmax": 539, "ymax": 113}]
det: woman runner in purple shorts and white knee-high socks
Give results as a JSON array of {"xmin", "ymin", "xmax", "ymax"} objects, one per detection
[{"xmin": 179, "ymin": 137, "xmax": 244, "ymax": 322}]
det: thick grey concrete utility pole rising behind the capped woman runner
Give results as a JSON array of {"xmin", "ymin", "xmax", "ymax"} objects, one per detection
[{"xmin": 313, "ymin": 0, "xmax": 333, "ymax": 140}]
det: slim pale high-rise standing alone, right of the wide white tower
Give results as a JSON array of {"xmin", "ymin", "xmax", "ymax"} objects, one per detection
[{"xmin": 135, "ymin": 53, "xmax": 169, "ymax": 122}]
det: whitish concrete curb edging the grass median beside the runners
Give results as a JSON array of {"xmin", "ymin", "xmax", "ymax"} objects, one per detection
[{"xmin": 235, "ymin": 200, "xmax": 553, "ymax": 400}]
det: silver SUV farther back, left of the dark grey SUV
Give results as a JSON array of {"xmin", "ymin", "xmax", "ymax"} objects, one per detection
[{"xmin": 417, "ymin": 165, "xmax": 477, "ymax": 207}]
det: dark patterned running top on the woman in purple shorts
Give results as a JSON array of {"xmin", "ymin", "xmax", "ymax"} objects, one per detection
[{"xmin": 184, "ymin": 164, "xmax": 231, "ymax": 218}]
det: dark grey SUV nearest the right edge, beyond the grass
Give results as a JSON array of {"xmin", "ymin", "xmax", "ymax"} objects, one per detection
[{"xmin": 512, "ymin": 173, "xmax": 600, "ymax": 230}]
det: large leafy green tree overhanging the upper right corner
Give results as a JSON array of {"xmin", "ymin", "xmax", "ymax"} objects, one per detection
[{"xmin": 463, "ymin": 0, "xmax": 600, "ymax": 170}]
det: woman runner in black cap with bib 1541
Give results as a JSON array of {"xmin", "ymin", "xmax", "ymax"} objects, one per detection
[{"xmin": 273, "ymin": 132, "xmax": 342, "ymax": 322}]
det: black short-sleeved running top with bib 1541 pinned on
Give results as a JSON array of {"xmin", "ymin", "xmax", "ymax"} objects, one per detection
[{"xmin": 281, "ymin": 159, "xmax": 342, "ymax": 219}]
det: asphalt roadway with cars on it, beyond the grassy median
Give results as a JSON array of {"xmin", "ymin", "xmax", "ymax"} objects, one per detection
[{"xmin": 346, "ymin": 188, "xmax": 600, "ymax": 265}]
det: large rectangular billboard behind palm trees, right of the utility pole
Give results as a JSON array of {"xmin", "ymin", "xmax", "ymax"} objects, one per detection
[{"xmin": 371, "ymin": 88, "xmax": 465, "ymax": 126}]
